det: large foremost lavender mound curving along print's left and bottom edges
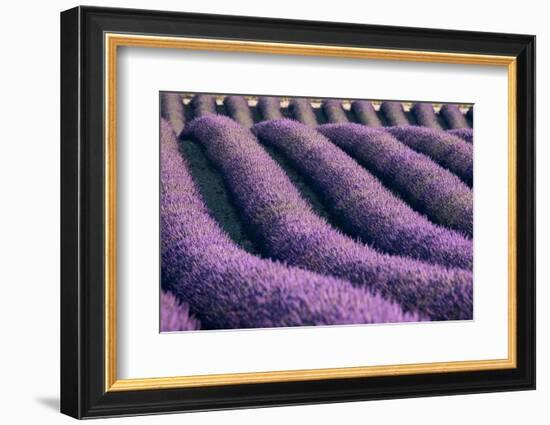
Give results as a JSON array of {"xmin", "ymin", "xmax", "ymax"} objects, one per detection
[{"xmin": 160, "ymin": 115, "xmax": 419, "ymax": 329}]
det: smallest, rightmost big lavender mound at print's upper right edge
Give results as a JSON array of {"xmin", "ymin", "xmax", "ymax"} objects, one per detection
[{"xmin": 385, "ymin": 126, "xmax": 474, "ymax": 187}]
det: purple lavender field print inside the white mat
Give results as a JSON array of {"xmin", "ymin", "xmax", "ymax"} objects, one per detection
[{"xmin": 159, "ymin": 92, "xmax": 473, "ymax": 332}]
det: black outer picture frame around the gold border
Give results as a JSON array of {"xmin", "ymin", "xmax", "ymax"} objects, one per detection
[{"xmin": 61, "ymin": 7, "xmax": 535, "ymax": 418}]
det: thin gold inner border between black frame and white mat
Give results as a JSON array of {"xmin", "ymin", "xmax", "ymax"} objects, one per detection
[{"xmin": 104, "ymin": 33, "xmax": 517, "ymax": 392}]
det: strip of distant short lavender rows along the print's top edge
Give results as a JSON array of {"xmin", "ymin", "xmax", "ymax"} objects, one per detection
[{"xmin": 169, "ymin": 95, "xmax": 473, "ymax": 134}]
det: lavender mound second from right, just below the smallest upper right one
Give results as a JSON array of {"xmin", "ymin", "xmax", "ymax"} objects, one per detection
[{"xmin": 317, "ymin": 124, "xmax": 473, "ymax": 237}]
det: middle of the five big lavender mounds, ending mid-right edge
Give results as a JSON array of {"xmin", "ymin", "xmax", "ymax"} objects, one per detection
[{"xmin": 253, "ymin": 120, "xmax": 472, "ymax": 269}]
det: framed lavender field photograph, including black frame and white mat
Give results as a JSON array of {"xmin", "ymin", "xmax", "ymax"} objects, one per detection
[{"xmin": 61, "ymin": 7, "xmax": 535, "ymax": 418}]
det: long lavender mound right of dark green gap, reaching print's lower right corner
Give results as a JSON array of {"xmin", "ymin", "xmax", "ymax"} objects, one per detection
[{"xmin": 185, "ymin": 116, "xmax": 473, "ymax": 320}]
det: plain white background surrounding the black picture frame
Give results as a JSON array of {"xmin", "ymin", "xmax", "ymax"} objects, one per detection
[{"xmin": 0, "ymin": 0, "xmax": 550, "ymax": 425}]
